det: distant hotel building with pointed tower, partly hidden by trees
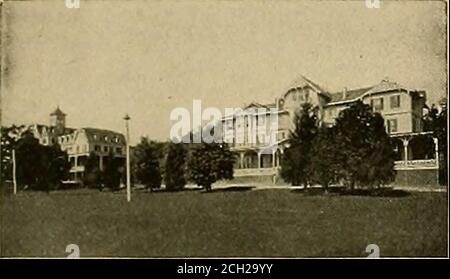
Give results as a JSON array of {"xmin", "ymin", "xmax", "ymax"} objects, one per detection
[{"xmin": 30, "ymin": 107, "xmax": 126, "ymax": 182}]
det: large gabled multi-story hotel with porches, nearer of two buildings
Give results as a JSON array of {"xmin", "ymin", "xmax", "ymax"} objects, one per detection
[{"xmin": 222, "ymin": 76, "xmax": 439, "ymax": 187}]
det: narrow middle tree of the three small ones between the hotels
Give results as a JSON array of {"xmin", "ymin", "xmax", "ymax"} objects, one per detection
[{"xmin": 164, "ymin": 142, "xmax": 187, "ymax": 190}]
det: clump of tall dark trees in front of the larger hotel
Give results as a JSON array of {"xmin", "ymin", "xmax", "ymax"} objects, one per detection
[{"xmin": 281, "ymin": 102, "xmax": 395, "ymax": 192}]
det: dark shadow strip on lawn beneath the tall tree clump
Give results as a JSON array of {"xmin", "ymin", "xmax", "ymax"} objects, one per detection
[{"xmin": 292, "ymin": 186, "xmax": 411, "ymax": 198}]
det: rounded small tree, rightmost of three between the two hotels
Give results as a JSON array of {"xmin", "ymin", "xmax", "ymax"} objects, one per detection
[{"xmin": 187, "ymin": 142, "xmax": 234, "ymax": 192}]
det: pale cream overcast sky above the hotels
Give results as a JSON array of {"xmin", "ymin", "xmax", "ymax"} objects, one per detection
[{"xmin": 2, "ymin": 0, "xmax": 447, "ymax": 142}]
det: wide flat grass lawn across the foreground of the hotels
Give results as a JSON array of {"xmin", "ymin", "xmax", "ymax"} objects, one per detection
[{"xmin": 1, "ymin": 190, "xmax": 447, "ymax": 257}]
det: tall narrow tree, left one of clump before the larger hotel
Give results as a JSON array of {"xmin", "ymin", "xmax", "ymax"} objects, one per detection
[{"xmin": 280, "ymin": 103, "xmax": 318, "ymax": 188}]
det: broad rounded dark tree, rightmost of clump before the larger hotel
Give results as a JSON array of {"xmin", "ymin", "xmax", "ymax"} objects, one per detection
[{"xmin": 335, "ymin": 101, "xmax": 395, "ymax": 189}]
